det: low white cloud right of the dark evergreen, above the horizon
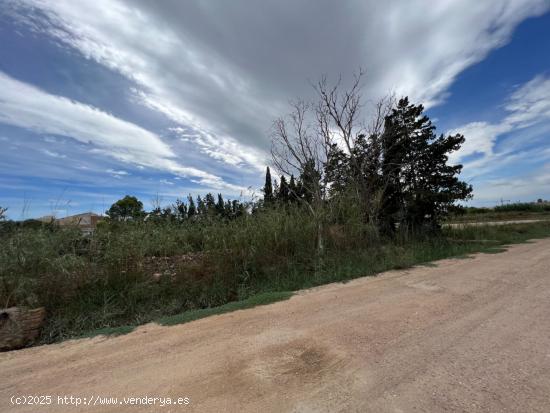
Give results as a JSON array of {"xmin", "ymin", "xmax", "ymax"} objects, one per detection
[{"xmin": 449, "ymin": 75, "xmax": 550, "ymax": 204}]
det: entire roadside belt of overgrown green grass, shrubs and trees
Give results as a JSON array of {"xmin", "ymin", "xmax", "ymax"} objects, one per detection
[{"xmin": 0, "ymin": 75, "xmax": 550, "ymax": 343}]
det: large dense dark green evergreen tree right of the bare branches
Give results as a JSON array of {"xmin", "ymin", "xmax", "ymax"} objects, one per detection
[{"xmin": 381, "ymin": 98, "xmax": 472, "ymax": 232}]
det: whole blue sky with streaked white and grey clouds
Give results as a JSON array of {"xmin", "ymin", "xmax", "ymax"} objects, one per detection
[{"xmin": 0, "ymin": 0, "xmax": 550, "ymax": 219}]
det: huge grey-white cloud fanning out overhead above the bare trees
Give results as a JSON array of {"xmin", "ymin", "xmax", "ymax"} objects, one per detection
[{"xmin": 7, "ymin": 0, "xmax": 548, "ymax": 170}]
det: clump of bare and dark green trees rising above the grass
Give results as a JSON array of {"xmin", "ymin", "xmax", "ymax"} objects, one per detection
[{"xmin": 266, "ymin": 73, "xmax": 472, "ymax": 236}]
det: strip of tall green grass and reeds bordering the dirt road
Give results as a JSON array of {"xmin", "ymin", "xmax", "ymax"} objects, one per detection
[{"xmin": 0, "ymin": 208, "xmax": 550, "ymax": 343}]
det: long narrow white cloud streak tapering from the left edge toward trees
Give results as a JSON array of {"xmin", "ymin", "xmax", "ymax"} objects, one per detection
[{"xmin": 0, "ymin": 72, "xmax": 247, "ymax": 192}]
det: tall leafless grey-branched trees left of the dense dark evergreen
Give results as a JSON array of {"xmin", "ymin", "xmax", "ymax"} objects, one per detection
[{"xmin": 271, "ymin": 70, "xmax": 402, "ymax": 245}]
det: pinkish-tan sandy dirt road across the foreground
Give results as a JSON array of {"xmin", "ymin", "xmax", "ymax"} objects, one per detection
[{"xmin": 0, "ymin": 239, "xmax": 550, "ymax": 412}]
